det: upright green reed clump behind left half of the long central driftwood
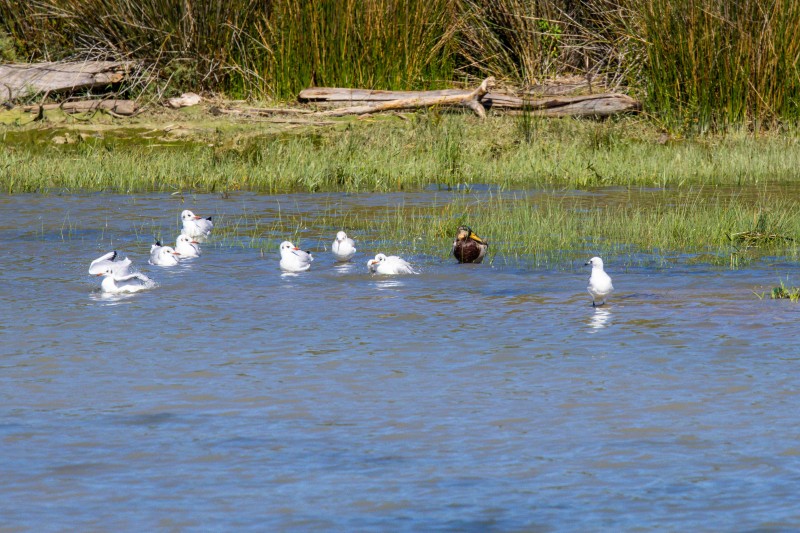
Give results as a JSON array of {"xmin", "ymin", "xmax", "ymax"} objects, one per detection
[{"xmin": 252, "ymin": 0, "xmax": 460, "ymax": 98}]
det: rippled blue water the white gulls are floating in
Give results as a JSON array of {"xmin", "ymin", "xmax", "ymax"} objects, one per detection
[{"xmin": 0, "ymin": 192, "xmax": 800, "ymax": 531}]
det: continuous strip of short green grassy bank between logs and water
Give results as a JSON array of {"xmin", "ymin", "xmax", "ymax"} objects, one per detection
[{"xmin": 0, "ymin": 112, "xmax": 800, "ymax": 193}]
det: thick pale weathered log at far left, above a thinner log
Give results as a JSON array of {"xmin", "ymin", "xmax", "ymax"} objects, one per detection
[{"xmin": 0, "ymin": 61, "xmax": 133, "ymax": 101}]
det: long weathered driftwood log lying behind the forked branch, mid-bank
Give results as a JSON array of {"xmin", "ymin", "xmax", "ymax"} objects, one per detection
[{"xmin": 298, "ymin": 82, "xmax": 641, "ymax": 117}]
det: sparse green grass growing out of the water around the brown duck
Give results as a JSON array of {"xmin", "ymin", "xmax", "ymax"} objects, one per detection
[{"xmin": 158, "ymin": 190, "xmax": 800, "ymax": 269}]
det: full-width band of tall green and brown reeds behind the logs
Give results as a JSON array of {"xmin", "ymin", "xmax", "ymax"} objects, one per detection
[{"xmin": 0, "ymin": 0, "xmax": 800, "ymax": 132}]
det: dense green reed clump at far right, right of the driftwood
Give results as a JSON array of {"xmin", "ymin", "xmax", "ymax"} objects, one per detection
[{"xmin": 640, "ymin": 0, "xmax": 800, "ymax": 132}]
